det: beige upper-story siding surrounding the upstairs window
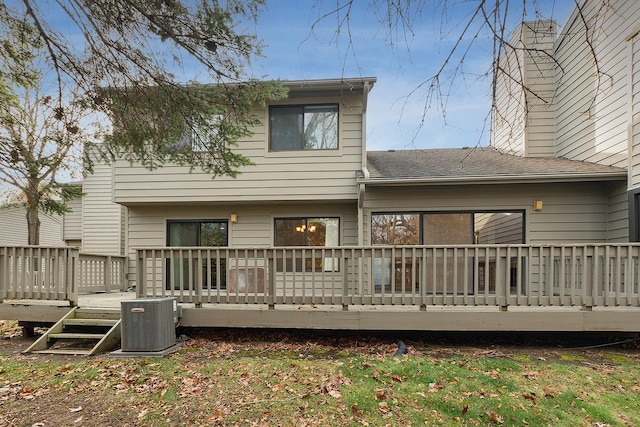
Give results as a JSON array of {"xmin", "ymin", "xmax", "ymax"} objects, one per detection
[{"xmin": 114, "ymin": 94, "xmax": 363, "ymax": 205}]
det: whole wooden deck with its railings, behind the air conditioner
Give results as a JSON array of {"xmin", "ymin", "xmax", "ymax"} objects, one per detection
[{"xmin": 0, "ymin": 244, "xmax": 640, "ymax": 332}]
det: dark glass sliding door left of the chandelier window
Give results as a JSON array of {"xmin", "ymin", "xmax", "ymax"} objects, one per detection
[{"xmin": 166, "ymin": 220, "xmax": 228, "ymax": 289}]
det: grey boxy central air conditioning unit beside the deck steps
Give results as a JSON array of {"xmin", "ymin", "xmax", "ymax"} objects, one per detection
[{"xmin": 120, "ymin": 298, "xmax": 179, "ymax": 352}]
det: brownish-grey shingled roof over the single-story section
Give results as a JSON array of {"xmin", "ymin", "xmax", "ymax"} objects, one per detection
[{"xmin": 360, "ymin": 148, "xmax": 627, "ymax": 184}]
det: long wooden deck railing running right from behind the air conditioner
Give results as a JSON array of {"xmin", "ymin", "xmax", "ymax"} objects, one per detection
[{"xmin": 136, "ymin": 244, "xmax": 640, "ymax": 309}]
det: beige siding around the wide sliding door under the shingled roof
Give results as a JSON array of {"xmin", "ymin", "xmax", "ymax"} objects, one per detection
[{"xmin": 364, "ymin": 183, "xmax": 609, "ymax": 244}]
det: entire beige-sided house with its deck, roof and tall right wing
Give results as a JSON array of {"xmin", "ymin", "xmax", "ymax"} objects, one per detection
[{"xmin": 0, "ymin": 0, "xmax": 640, "ymax": 331}]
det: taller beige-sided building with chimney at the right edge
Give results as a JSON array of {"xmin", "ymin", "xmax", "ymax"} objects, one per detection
[{"xmin": 492, "ymin": 0, "xmax": 640, "ymax": 242}]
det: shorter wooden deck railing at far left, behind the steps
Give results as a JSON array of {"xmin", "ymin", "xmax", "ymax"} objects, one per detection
[{"xmin": 0, "ymin": 246, "xmax": 126, "ymax": 304}]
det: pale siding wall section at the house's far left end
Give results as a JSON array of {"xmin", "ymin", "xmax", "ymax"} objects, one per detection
[{"xmin": 82, "ymin": 163, "xmax": 124, "ymax": 255}]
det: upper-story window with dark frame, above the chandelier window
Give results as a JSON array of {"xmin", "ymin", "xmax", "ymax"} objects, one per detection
[{"xmin": 269, "ymin": 104, "xmax": 338, "ymax": 151}]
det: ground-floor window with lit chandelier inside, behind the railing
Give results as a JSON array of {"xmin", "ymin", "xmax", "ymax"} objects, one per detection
[{"xmin": 274, "ymin": 218, "xmax": 340, "ymax": 272}]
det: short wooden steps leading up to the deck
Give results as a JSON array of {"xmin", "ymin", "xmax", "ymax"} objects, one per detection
[{"xmin": 24, "ymin": 307, "xmax": 120, "ymax": 356}]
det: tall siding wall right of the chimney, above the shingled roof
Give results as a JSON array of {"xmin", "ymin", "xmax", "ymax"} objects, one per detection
[{"xmin": 556, "ymin": 0, "xmax": 640, "ymax": 167}]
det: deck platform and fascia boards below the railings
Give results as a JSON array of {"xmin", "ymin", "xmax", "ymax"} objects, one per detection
[{"xmin": 0, "ymin": 292, "xmax": 640, "ymax": 332}]
